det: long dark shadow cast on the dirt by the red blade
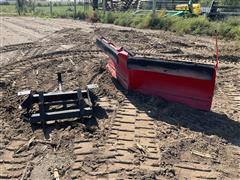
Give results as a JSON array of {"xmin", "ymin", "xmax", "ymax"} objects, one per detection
[{"xmin": 112, "ymin": 79, "xmax": 240, "ymax": 146}]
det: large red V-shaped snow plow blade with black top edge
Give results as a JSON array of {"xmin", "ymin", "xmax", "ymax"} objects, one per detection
[{"xmin": 96, "ymin": 38, "xmax": 217, "ymax": 111}]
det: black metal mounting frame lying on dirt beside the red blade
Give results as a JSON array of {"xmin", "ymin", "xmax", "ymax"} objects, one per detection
[{"xmin": 18, "ymin": 73, "xmax": 98, "ymax": 124}]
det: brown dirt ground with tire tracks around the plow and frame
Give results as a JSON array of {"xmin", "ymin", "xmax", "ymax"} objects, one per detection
[{"xmin": 0, "ymin": 17, "xmax": 240, "ymax": 180}]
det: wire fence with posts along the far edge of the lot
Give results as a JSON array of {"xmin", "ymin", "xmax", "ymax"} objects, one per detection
[{"xmin": 0, "ymin": 0, "xmax": 240, "ymax": 19}]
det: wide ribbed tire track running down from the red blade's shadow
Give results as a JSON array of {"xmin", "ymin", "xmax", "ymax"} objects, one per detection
[{"xmin": 109, "ymin": 99, "xmax": 160, "ymax": 170}]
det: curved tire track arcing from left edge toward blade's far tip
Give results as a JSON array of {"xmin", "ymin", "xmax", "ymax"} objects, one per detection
[{"xmin": 0, "ymin": 46, "xmax": 99, "ymax": 100}]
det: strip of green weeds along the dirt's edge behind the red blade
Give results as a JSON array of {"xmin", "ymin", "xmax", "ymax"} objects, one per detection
[{"xmin": 96, "ymin": 12, "xmax": 240, "ymax": 40}]
